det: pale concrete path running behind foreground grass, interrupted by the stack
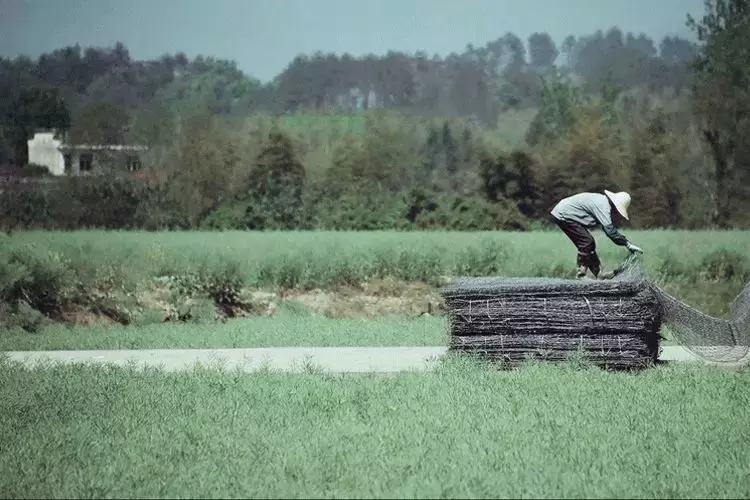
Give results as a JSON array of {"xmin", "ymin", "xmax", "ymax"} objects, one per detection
[{"xmin": 5, "ymin": 346, "xmax": 724, "ymax": 373}]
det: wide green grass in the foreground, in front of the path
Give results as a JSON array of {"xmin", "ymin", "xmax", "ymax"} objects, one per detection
[{"xmin": 0, "ymin": 360, "xmax": 750, "ymax": 498}]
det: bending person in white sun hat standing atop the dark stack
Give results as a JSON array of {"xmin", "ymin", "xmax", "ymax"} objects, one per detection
[{"xmin": 552, "ymin": 189, "xmax": 643, "ymax": 278}]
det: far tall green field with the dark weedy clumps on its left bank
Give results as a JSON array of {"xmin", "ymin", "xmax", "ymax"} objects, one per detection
[{"xmin": 0, "ymin": 231, "xmax": 750, "ymax": 330}]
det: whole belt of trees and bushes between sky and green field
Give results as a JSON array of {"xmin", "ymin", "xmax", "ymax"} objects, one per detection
[{"xmin": 0, "ymin": 0, "xmax": 750, "ymax": 229}]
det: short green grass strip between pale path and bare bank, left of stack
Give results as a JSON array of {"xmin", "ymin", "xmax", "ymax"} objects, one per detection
[{"xmin": 0, "ymin": 309, "xmax": 448, "ymax": 351}]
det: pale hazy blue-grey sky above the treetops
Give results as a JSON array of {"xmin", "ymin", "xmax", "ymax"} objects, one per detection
[{"xmin": 0, "ymin": 0, "xmax": 703, "ymax": 81}]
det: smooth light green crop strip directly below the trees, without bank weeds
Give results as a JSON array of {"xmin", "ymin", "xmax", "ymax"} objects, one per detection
[{"xmin": 7, "ymin": 231, "xmax": 750, "ymax": 286}]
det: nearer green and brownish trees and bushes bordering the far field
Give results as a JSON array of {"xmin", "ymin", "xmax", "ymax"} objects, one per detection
[{"xmin": 0, "ymin": 94, "xmax": 746, "ymax": 230}]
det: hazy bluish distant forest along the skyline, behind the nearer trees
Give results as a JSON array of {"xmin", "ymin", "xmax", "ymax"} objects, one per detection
[{"xmin": 0, "ymin": 27, "xmax": 697, "ymax": 159}]
